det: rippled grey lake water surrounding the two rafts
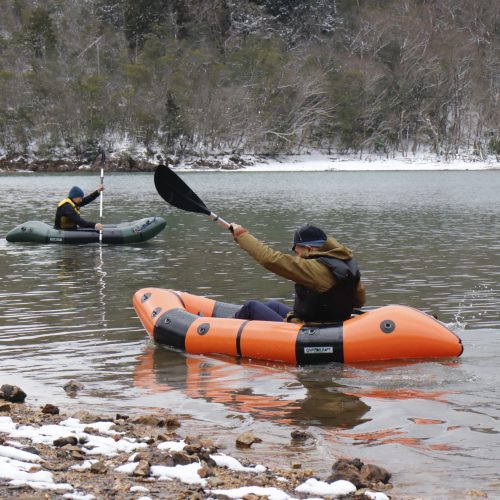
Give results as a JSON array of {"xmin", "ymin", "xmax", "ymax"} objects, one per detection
[{"xmin": 0, "ymin": 171, "xmax": 500, "ymax": 498}]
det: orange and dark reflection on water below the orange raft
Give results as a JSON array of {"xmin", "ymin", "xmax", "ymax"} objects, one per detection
[{"xmin": 134, "ymin": 347, "xmax": 369, "ymax": 428}]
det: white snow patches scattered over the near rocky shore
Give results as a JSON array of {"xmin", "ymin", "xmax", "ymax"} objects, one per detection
[{"xmin": 0, "ymin": 417, "xmax": 388, "ymax": 500}]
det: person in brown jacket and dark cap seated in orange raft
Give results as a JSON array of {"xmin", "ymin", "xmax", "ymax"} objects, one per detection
[{"xmin": 231, "ymin": 224, "xmax": 366, "ymax": 323}]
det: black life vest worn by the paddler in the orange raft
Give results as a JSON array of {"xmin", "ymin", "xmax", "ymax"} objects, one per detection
[{"xmin": 293, "ymin": 257, "xmax": 361, "ymax": 323}]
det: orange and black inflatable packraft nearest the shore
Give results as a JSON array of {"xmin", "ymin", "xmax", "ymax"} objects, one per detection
[{"xmin": 134, "ymin": 288, "xmax": 463, "ymax": 365}]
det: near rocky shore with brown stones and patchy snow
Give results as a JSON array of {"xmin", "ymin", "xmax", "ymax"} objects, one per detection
[{"xmin": 0, "ymin": 383, "xmax": 398, "ymax": 500}]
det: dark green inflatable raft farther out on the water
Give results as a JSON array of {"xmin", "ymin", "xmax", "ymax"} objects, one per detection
[{"xmin": 5, "ymin": 217, "xmax": 167, "ymax": 245}]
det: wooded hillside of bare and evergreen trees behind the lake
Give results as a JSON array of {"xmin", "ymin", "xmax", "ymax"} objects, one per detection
[{"xmin": 0, "ymin": 0, "xmax": 500, "ymax": 163}]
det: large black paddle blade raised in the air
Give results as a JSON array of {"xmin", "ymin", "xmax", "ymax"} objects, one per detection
[{"xmin": 155, "ymin": 165, "xmax": 211, "ymax": 215}]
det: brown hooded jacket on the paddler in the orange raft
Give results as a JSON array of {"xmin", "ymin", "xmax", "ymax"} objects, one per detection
[{"xmin": 234, "ymin": 230, "xmax": 366, "ymax": 307}]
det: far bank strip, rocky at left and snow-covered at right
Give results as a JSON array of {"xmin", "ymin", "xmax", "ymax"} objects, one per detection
[{"xmin": 0, "ymin": 153, "xmax": 500, "ymax": 173}]
